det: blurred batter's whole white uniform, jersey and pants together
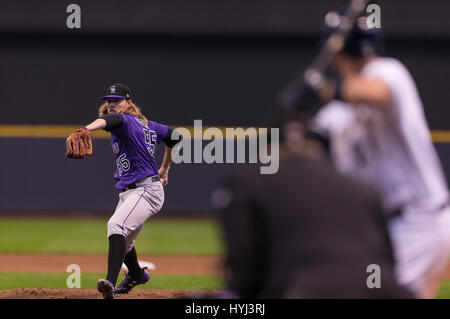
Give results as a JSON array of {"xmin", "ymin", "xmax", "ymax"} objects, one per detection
[{"xmin": 314, "ymin": 58, "xmax": 450, "ymax": 297}]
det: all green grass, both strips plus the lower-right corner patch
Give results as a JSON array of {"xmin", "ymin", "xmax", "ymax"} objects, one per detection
[{"xmin": 0, "ymin": 217, "xmax": 450, "ymax": 299}]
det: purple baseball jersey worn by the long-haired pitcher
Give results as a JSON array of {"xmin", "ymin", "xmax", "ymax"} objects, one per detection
[{"xmin": 111, "ymin": 114, "xmax": 168, "ymax": 189}]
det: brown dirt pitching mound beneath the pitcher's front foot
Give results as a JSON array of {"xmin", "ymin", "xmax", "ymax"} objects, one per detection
[{"xmin": 0, "ymin": 288, "xmax": 218, "ymax": 299}]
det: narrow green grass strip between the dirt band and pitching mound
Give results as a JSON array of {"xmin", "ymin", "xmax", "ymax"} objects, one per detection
[{"xmin": 0, "ymin": 272, "xmax": 223, "ymax": 290}]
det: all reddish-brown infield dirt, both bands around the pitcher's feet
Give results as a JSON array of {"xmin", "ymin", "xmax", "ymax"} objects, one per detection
[{"xmin": 0, "ymin": 254, "xmax": 223, "ymax": 299}]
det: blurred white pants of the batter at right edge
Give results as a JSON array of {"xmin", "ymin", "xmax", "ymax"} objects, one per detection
[{"xmin": 389, "ymin": 207, "xmax": 450, "ymax": 298}]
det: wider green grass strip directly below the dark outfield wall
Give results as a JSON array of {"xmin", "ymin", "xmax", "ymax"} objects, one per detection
[{"xmin": 0, "ymin": 218, "xmax": 223, "ymax": 255}]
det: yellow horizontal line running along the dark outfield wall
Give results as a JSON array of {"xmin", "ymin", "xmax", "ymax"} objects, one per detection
[{"xmin": 0, "ymin": 125, "xmax": 450, "ymax": 143}]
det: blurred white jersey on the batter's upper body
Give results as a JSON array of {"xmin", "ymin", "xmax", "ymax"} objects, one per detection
[{"xmin": 314, "ymin": 58, "xmax": 448, "ymax": 212}]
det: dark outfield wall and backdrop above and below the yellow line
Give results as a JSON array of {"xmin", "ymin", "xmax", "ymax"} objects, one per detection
[{"xmin": 0, "ymin": 0, "xmax": 450, "ymax": 215}]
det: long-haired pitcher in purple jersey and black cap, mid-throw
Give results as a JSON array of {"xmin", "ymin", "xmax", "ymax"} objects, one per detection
[{"xmin": 66, "ymin": 84, "xmax": 178, "ymax": 299}]
